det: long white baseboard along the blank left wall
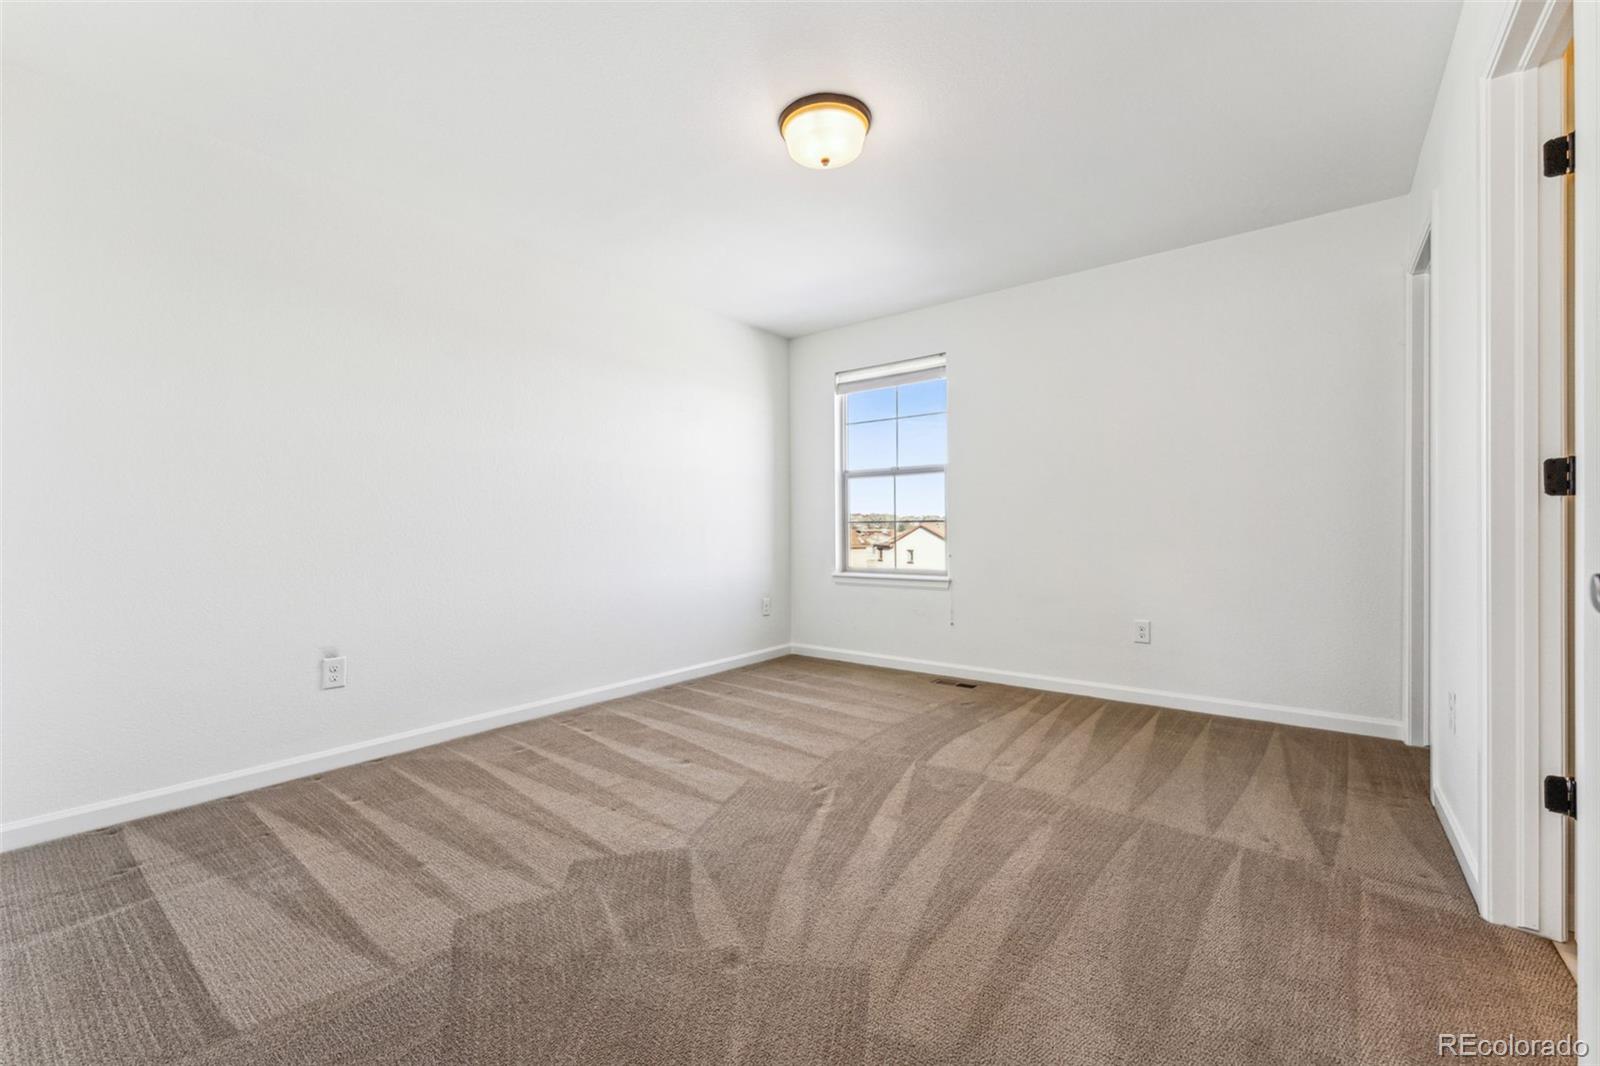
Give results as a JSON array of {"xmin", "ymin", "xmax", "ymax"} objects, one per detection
[{"xmin": 0, "ymin": 643, "xmax": 789, "ymax": 852}]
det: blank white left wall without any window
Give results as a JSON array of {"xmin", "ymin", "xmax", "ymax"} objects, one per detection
[{"xmin": 0, "ymin": 64, "xmax": 789, "ymax": 845}]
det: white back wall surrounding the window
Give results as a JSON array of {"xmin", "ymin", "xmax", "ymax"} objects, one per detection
[{"xmin": 790, "ymin": 198, "xmax": 1408, "ymax": 736}]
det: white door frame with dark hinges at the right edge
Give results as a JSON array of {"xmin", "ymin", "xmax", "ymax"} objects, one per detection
[{"xmin": 1478, "ymin": 0, "xmax": 1573, "ymax": 940}]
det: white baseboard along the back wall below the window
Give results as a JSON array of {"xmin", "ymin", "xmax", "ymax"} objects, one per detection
[{"xmin": 790, "ymin": 643, "xmax": 1405, "ymax": 739}]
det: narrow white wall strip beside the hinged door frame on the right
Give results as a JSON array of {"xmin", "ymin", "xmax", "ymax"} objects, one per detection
[{"xmin": 1405, "ymin": 3, "xmax": 1506, "ymax": 888}]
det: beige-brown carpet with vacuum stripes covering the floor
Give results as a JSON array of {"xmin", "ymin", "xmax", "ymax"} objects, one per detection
[{"xmin": 0, "ymin": 658, "xmax": 1573, "ymax": 1066}]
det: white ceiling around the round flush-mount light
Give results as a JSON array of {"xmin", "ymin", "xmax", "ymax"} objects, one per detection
[{"xmin": 5, "ymin": 2, "xmax": 1458, "ymax": 336}]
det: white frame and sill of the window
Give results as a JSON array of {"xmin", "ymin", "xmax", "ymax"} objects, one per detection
[{"xmin": 834, "ymin": 352, "xmax": 950, "ymax": 589}]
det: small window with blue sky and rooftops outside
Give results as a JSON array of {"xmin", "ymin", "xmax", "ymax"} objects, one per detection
[{"xmin": 834, "ymin": 355, "xmax": 949, "ymax": 578}]
